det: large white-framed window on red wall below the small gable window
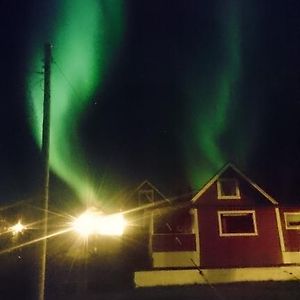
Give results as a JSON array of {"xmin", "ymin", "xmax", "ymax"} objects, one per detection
[{"xmin": 218, "ymin": 210, "xmax": 257, "ymax": 236}]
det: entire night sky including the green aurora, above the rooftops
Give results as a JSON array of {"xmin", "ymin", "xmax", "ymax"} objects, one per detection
[{"xmin": 0, "ymin": 0, "xmax": 300, "ymax": 209}]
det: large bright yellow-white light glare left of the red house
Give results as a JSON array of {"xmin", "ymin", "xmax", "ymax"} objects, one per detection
[{"xmin": 72, "ymin": 211, "xmax": 126, "ymax": 237}]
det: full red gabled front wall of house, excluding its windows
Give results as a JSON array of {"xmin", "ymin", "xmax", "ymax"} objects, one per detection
[{"xmin": 196, "ymin": 171, "xmax": 283, "ymax": 268}]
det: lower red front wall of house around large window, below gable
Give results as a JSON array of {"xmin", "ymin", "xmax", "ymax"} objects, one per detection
[{"xmin": 198, "ymin": 206, "xmax": 282, "ymax": 268}]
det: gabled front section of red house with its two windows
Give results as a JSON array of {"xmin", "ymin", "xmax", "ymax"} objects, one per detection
[{"xmin": 192, "ymin": 165, "xmax": 282, "ymax": 268}]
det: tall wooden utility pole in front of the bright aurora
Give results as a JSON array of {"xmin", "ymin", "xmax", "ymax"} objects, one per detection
[{"xmin": 38, "ymin": 43, "xmax": 52, "ymax": 300}]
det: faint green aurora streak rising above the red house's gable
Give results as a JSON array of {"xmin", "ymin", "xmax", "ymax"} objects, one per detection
[{"xmin": 186, "ymin": 0, "xmax": 241, "ymax": 188}]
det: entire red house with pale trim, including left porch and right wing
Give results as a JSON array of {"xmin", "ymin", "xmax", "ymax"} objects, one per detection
[{"xmin": 135, "ymin": 164, "xmax": 300, "ymax": 286}]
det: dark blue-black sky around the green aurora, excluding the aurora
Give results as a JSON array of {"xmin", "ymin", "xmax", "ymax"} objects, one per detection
[{"xmin": 0, "ymin": 0, "xmax": 300, "ymax": 203}]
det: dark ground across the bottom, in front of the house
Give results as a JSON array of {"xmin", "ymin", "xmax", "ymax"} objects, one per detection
[{"xmin": 0, "ymin": 248, "xmax": 300, "ymax": 300}]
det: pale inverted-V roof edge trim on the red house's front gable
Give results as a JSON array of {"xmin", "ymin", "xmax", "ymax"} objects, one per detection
[{"xmin": 191, "ymin": 163, "xmax": 278, "ymax": 205}]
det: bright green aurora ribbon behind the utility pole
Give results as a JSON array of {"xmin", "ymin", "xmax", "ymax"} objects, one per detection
[{"xmin": 28, "ymin": 0, "xmax": 124, "ymax": 200}]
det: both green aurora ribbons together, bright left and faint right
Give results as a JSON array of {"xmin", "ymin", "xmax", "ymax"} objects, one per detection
[{"xmin": 28, "ymin": 0, "xmax": 250, "ymax": 201}]
